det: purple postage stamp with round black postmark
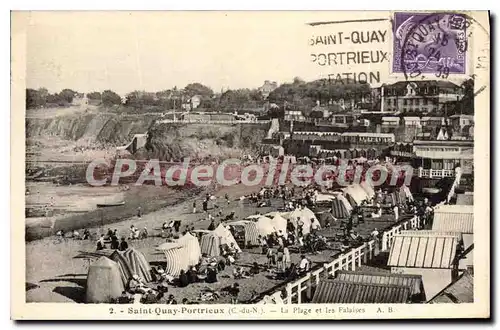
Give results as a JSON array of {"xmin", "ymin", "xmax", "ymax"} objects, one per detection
[{"xmin": 392, "ymin": 12, "xmax": 470, "ymax": 78}]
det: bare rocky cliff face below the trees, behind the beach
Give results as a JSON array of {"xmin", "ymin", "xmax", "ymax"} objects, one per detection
[{"xmin": 26, "ymin": 113, "xmax": 271, "ymax": 160}]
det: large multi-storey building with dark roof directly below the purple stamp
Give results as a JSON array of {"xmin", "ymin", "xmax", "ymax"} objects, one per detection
[{"xmin": 380, "ymin": 80, "xmax": 464, "ymax": 113}]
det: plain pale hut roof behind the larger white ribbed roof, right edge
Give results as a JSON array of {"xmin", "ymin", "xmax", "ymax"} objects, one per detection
[{"xmin": 432, "ymin": 205, "xmax": 474, "ymax": 234}]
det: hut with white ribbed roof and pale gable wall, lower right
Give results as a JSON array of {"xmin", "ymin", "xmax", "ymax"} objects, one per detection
[{"xmin": 387, "ymin": 231, "xmax": 459, "ymax": 297}]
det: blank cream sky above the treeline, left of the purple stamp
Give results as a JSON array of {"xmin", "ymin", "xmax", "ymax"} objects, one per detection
[{"xmin": 26, "ymin": 12, "xmax": 396, "ymax": 95}]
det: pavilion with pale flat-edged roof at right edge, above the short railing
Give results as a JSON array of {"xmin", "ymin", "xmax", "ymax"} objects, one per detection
[{"xmin": 413, "ymin": 140, "xmax": 474, "ymax": 178}]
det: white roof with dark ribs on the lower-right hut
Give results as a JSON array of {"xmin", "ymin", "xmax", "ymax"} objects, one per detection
[{"xmin": 387, "ymin": 234, "xmax": 458, "ymax": 269}]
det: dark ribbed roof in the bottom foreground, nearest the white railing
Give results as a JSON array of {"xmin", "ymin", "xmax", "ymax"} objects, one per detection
[{"xmin": 312, "ymin": 280, "xmax": 410, "ymax": 304}]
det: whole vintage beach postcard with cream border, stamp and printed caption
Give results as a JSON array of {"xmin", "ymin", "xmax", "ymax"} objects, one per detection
[{"xmin": 11, "ymin": 10, "xmax": 491, "ymax": 320}]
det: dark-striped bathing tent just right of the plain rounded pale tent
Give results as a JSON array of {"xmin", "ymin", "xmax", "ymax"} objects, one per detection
[{"xmin": 109, "ymin": 248, "xmax": 153, "ymax": 286}]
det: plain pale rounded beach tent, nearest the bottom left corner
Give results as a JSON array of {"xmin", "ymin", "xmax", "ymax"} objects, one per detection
[{"xmin": 85, "ymin": 257, "xmax": 125, "ymax": 303}]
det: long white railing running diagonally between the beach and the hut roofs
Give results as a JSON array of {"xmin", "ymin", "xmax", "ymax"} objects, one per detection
[{"xmin": 262, "ymin": 216, "xmax": 420, "ymax": 304}]
